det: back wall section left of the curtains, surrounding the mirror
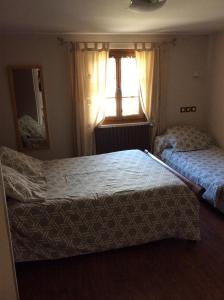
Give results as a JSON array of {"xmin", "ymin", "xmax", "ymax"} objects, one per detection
[{"xmin": 0, "ymin": 35, "xmax": 73, "ymax": 159}]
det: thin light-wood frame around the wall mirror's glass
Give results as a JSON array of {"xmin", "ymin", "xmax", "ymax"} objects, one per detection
[{"xmin": 7, "ymin": 64, "xmax": 50, "ymax": 151}]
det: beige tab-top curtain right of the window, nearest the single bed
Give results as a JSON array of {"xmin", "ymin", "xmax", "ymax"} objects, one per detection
[{"xmin": 135, "ymin": 44, "xmax": 167, "ymax": 145}]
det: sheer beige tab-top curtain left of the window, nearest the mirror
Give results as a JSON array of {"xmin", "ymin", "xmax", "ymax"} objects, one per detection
[{"xmin": 73, "ymin": 43, "xmax": 109, "ymax": 156}]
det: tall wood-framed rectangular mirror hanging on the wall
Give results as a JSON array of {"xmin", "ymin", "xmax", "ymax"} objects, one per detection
[{"xmin": 9, "ymin": 65, "xmax": 49, "ymax": 150}]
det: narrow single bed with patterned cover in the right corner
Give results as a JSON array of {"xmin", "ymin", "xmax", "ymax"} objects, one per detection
[{"xmin": 155, "ymin": 126, "xmax": 224, "ymax": 212}]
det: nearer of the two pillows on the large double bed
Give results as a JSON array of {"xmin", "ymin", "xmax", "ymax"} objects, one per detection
[{"xmin": 2, "ymin": 165, "xmax": 46, "ymax": 203}]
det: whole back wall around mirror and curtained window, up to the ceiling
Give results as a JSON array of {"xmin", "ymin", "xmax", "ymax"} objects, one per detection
[{"xmin": 0, "ymin": 35, "xmax": 208, "ymax": 159}]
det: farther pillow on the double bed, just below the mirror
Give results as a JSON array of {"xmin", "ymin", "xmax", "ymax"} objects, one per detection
[{"xmin": 0, "ymin": 147, "xmax": 43, "ymax": 176}]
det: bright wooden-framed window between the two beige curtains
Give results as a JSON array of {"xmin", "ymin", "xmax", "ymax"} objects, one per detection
[{"xmin": 105, "ymin": 50, "xmax": 145, "ymax": 123}]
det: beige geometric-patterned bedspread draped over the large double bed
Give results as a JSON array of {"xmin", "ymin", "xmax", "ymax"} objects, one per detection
[{"xmin": 8, "ymin": 150, "xmax": 200, "ymax": 262}]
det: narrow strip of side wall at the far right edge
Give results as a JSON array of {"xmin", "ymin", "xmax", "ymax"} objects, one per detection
[{"xmin": 208, "ymin": 32, "xmax": 224, "ymax": 148}]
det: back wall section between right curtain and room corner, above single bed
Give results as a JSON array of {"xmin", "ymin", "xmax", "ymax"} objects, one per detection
[{"xmin": 167, "ymin": 36, "xmax": 208, "ymax": 129}]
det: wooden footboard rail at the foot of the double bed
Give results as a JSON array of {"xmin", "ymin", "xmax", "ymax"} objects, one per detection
[{"xmin": 144, "ymin": 150, "xmax": 205, "ymax": 200}]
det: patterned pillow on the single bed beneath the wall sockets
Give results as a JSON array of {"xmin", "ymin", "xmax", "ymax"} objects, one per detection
[{"xmin": 166, "ymin": 125, "xmax": 213, "ymax": 151}]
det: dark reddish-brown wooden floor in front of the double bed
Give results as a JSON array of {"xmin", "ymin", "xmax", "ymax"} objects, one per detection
[{"xmin": 16, "ymin": 204, "xmax": 224, "ymax": 300}]
